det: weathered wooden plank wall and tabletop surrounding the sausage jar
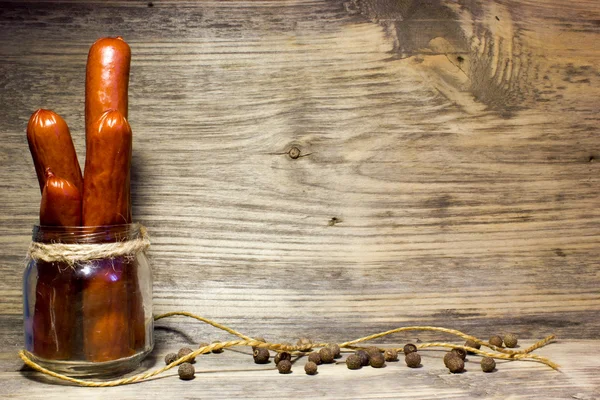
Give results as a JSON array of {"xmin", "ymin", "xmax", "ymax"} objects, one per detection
[{"xmin": 0, "ymin": 0, "xmax": 600, "ymax": 399}]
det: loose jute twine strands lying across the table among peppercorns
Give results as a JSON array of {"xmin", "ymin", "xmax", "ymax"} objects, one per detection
[{"xmin": 19, "ymin": 311, "xmax": 559, "ymax": 387}]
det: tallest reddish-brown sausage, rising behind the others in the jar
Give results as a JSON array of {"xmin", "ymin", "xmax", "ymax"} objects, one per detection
[{"xmin": 85, "ymin": 36, "xmax": 131, "ymax": 139}]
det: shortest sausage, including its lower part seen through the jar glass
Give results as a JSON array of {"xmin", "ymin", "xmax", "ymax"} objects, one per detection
[{"xmin": 33, "ymin": 168, "xmax": 81, "ymax": 360}]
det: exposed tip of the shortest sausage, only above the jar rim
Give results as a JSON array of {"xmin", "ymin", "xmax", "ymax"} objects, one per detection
[{"xmin": 40, "ymin": 168, "xmax": 81, "ymax": 226}]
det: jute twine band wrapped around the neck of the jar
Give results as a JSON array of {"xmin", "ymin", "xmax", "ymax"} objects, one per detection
[{"xmin": 27, "ymin": 225, "xmax": 150, "ymax": 266}]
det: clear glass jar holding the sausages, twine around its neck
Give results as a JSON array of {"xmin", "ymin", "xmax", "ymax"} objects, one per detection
[{"xmin": 23, "ymin": 224, "xmax": 154, "ymax": 376}]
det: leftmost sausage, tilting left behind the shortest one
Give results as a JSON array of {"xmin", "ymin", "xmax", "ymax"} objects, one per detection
[{"xmin": 27, "ymin": 109, "xmax": 83, "ymax": 193}]
